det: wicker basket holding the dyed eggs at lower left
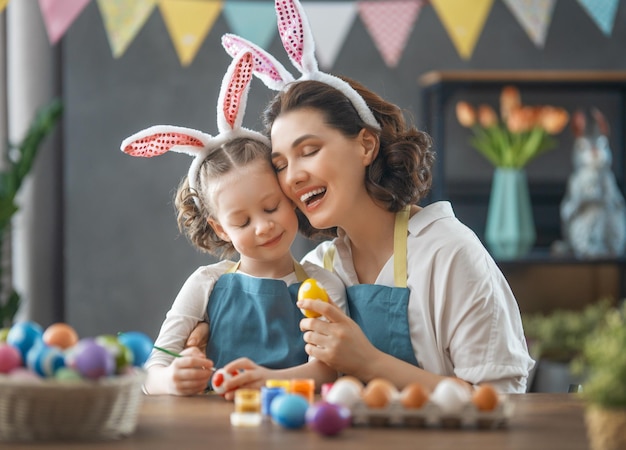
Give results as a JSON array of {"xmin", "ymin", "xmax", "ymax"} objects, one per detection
[{"xmin": 0, "ymin": 371, "xmax": 145, "ymax": 441}]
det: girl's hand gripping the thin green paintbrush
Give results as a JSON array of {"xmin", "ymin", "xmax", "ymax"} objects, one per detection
[{"xmin": 166, "ymin": 347, "xmax": 213, "ymax": 395}]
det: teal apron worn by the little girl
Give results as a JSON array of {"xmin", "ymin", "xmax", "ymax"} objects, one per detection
[{"xmin": 207, "ymin": 261, "xmax": 308, "ymax": 369}]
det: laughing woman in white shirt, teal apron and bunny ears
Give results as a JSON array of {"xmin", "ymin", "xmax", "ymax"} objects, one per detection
[{"xmin": 210, "ymin": 0, "xmax": 533, "ymax": 392}]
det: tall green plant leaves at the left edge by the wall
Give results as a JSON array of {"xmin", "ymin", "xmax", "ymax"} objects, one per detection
[{"xmin": 0, "ymin": 99, "xmax": 63, "ymax": 328}]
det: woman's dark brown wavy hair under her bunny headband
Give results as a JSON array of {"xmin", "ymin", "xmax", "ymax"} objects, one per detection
[{"xmin": 263, "ymin": 77, "xmax": 435, "ymax": 238}]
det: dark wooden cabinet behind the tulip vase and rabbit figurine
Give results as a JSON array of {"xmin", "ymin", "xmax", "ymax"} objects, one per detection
[{"xmin": 419, "ymin": 71, "xmax": 626, "ymax": 312}]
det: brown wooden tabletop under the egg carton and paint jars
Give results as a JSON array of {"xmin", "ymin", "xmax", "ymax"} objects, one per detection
[{"xmin": 7, "ymin": 393, "xmax": 589, "ymax": 450}]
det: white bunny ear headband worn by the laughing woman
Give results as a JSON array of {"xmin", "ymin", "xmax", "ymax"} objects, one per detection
[{"xmin": 222, "ymin": 0, "xmax": 380, "ymax": 130}]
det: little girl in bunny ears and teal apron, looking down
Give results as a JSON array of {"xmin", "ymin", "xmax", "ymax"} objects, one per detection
[{"xmin": 122, "ymin": 53, "xmax": 345, "ymax": 395}]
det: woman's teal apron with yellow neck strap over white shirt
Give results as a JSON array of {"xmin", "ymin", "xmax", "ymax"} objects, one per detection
[{"xmin": 324, "ymin": 206, "xmax": 418, "ymax": 366}]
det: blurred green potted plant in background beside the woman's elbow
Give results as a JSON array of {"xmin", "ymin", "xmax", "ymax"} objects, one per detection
[{"xmin": 522, "ymin": 299, "xmax": 613, "ymax": 392}]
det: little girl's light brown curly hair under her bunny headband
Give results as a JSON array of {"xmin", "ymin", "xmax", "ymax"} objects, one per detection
[{"xmin": 174, "ymin": 138, "xmax": 272, "ymax": 257}]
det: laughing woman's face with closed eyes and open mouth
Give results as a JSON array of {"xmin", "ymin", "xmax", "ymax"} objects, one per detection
[{"xmin": 271, "ymin": 109, "xmax": 378, "ymax": 229}]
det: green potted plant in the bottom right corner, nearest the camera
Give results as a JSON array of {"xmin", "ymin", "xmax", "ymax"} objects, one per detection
[{"xmin": 572, "ymin": 303, "xmax": 626, "ymax": 450}]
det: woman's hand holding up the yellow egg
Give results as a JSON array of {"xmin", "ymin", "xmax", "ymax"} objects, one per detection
[{"xmin": 297, "ymin": 300, "xmax": 382, "ymax": 380}]
